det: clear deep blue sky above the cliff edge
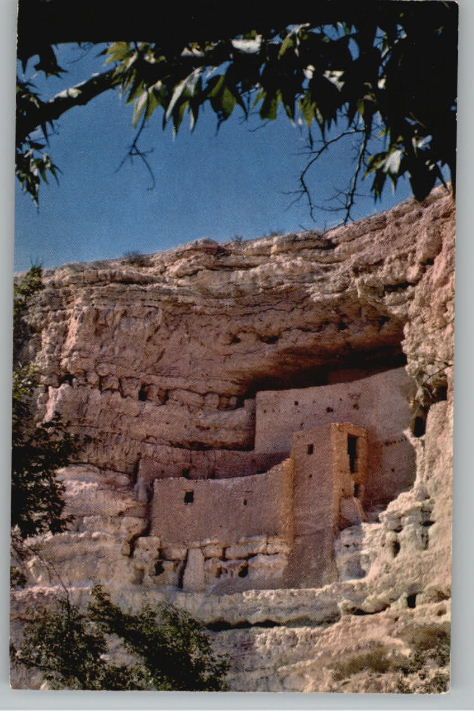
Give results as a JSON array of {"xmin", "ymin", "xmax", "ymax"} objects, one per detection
[{"xmin": 15, "ymin": 46, "xmax": 410, "ymax": 270}]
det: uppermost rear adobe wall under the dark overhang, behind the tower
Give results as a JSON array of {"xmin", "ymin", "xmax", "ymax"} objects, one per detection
[{"xmin": 255, "ymin": 368, "xmax": 415, "ymax": 507}]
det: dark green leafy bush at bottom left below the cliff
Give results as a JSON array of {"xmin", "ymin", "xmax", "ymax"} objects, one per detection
[{"xmin": 12, "ymin": 586, "xmax": 228, "ymax": 690}]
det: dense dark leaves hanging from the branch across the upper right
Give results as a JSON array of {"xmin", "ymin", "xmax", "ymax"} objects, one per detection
[{"xmin": 108, "ymin": 6, "xmax": 456, "ymax": 214}]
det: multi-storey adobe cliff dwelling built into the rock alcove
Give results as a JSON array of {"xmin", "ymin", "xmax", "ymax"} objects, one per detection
[{"xmin": 137, "ymin": 368, "xmax": 415, "ymax": 592}]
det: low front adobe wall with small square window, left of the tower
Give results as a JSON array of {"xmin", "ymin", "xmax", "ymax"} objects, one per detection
[{"xmin": 150, "ymin": 459, "xmax": 293, "ymax": 591}]
